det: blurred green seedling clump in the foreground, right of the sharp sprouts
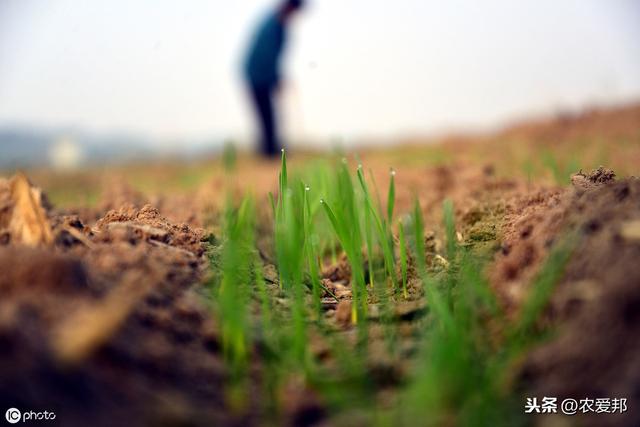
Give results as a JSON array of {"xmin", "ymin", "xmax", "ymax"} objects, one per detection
[{"xmin": 397, "ymin": 199, "xmax": 575, "ymax": 426}]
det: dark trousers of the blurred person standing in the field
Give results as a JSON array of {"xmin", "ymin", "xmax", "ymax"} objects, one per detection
[{"xmin": 249, "ymin": 83, "xmax": 281, "ymax": 157}]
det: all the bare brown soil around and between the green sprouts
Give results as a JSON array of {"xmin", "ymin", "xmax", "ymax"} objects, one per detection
[{"xmin": 0, "ymin": 106, "xmax": 640, "ymax": 426}]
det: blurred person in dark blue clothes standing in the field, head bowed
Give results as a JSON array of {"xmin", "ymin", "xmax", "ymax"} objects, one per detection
[{"xmin": 244, "ymin": 0, "xmax": 304, "ymax": 157}]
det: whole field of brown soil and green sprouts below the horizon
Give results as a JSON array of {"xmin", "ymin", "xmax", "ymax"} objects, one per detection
[{"xmin": 0, "ymin": 105, "xmax": 640, "ymax": 426}]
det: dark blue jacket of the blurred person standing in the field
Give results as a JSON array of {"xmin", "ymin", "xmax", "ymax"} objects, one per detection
[{"xmin": 244, "ymin": 13, "xmax": 286, "ymax": 87}]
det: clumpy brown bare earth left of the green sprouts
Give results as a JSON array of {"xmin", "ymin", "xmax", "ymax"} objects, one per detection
[{"xmin": 0, "ymin": 178, "xmax": 235, "ymax": 426}]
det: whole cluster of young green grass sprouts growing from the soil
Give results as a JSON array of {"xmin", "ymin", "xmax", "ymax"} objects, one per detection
[{"xmin": 212, "ymin": 155, "xmax": 575, "ymax": 425}]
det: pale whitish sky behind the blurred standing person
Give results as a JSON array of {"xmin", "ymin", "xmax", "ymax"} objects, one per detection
[{"xmin": 0, "ymin": 0, "xmax": 640, "ymax": 147}]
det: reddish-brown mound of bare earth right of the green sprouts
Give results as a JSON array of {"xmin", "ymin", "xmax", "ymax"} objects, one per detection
[{"xmin": 492, "ymin": 168, "xmax": 640, "ymax": 426}]
